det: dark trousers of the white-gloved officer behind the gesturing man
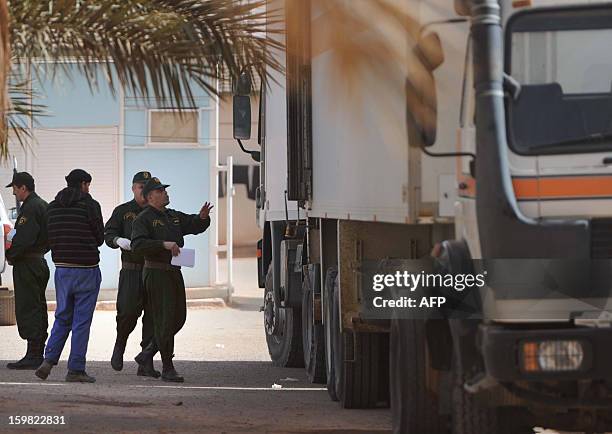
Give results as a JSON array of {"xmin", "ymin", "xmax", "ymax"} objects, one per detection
[{"xmin": 117, "ymin": 269, "xmax": 153, "ymax": 349}]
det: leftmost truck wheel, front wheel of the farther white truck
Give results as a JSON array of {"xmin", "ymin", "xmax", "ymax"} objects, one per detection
[{"xmin": 264, "ymin": 265, "xmax": 304, "ymax": 368}]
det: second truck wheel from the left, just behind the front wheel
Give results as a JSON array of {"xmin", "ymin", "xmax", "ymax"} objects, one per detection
[{"xmin": 302, "ymin": 273, "xmax": 326, "ymax": 384}]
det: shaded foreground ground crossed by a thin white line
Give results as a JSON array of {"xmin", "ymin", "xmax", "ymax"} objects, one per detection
[{"xmin": 0, "ymin": 360, "xmax": 390, "ymax": 433}]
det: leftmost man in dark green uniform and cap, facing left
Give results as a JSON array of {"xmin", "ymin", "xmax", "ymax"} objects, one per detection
[{"xmin": 6, "ymin": 172, "xmax": 49, "ymax": 370}]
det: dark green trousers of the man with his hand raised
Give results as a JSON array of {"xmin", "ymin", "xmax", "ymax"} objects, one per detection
[{"xmin": 143, "ymin": 267, "xmax": 187, "ymax": 360}]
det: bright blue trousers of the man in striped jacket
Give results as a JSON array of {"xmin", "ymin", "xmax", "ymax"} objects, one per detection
[{"xmin": 45, "ymin": 267, "xmax": 102, "ymax": 371}]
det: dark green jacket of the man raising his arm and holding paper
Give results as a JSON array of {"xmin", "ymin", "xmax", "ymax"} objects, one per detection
[{"xmin": 132, "ymin": 206, "xmax": 210, "ymax": 264}]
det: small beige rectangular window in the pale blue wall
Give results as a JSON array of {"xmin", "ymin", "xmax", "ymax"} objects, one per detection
[{"xmin": 149, "ymin": 110, "xmax": 198, "ymax": 144}]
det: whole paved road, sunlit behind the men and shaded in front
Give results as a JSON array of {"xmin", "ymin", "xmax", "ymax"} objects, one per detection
[{"xmin": 0, "ymin": 304, "xmax": 391, "ymax": 433}]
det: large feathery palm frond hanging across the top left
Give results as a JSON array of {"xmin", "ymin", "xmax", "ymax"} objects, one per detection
[{"xmin": 9, "ymin": 0, "xmax": 282, "ymax": 109}]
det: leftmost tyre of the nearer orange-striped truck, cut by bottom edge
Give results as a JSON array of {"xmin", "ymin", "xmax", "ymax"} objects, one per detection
[{"xmin": 389, "ymin": 319, "xmax": 450, "ymax": 434}]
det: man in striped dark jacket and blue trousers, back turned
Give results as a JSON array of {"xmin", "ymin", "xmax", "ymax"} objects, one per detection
[{"xmin": 36, "ymin": 169, "xmax": 104, "ymax": 383}]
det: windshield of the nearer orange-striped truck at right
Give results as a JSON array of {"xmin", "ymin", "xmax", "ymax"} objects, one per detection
[{"xmin": 506, "ymin": 17, "xmax": 612, "ymax": 154}]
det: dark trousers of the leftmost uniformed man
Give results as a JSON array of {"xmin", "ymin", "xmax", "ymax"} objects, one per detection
[{"xmin": 13, "ymin": 258, "xmax": 49, "ymax": 343}]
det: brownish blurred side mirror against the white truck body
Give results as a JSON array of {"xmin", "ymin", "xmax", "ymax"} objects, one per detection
[{"xmin": 406, "ymin": 32, "xmax": 444, "ymax": 148}]
